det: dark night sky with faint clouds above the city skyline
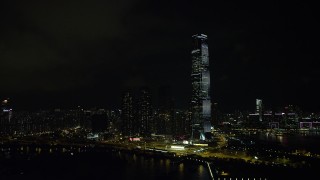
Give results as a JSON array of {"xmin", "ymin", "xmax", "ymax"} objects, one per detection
[{"xmin": 0, "ymin": 0, "xmax": 320, "ymax": 111}]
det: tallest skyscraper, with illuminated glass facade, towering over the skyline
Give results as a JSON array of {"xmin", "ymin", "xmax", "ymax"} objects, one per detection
[{"xmin": 191, "ymin": 34, "xmax": 211, "ymax": 139}]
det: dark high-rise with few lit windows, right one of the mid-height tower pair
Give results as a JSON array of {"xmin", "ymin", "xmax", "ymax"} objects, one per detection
[{"xmin": 137, "ymin": 87, "xmax": 154, "ymax": 136}]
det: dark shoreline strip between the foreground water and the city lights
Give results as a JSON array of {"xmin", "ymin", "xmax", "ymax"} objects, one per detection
[{"xmin": 0, "ymin": 143, "xmax": 313, "ymax": 178}]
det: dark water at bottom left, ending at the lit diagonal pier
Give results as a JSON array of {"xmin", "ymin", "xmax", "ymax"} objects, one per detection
[{"xmin": 0, "ymin": 151, "xmax": 210, "ymax": 180}]
